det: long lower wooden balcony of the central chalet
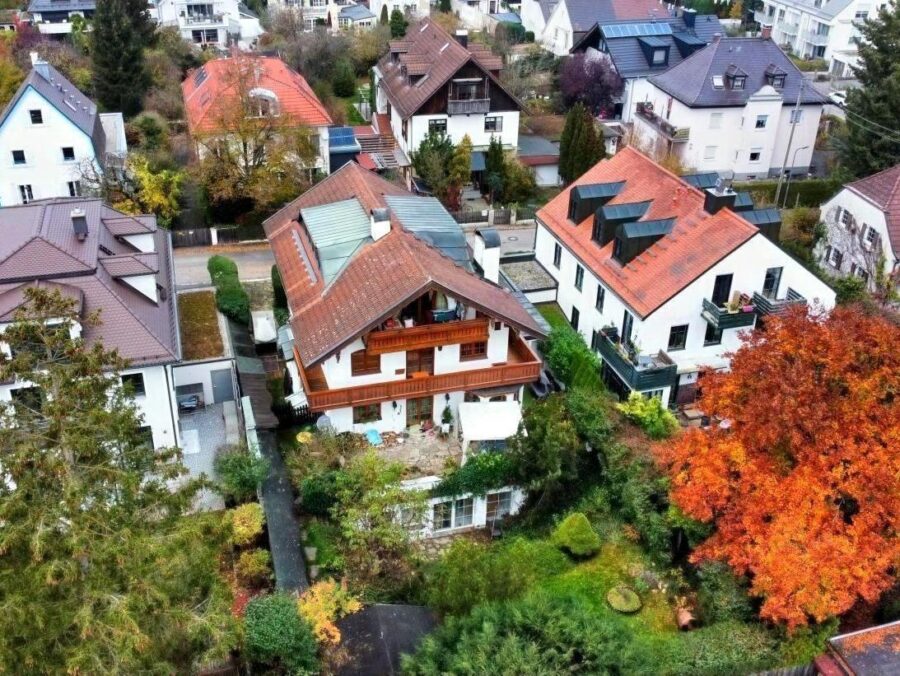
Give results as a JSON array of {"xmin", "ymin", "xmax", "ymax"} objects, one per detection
[{"xmin": 297, "ymin": 338, "xmax": 541, "ymax": 411}]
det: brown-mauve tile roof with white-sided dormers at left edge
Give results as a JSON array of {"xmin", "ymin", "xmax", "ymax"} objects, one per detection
[{"xmin": 0, "ymin": 198, "xmax": 180, "ymax": 365}]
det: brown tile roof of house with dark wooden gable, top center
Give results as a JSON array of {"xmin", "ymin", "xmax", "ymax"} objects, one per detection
[{"xmin": 378, "ymin": 19, "xmax": 515, "ymax": 120}]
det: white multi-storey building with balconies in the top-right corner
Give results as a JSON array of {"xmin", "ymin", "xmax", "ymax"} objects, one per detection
[{"xmin": 753, "ymin": 0, "xmax": 888, "ymax": 77}]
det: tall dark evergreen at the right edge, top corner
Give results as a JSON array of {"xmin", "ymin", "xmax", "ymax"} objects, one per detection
[{"xmin": 839, "ymin": 3, "xmax": 900, "ymax": 176}]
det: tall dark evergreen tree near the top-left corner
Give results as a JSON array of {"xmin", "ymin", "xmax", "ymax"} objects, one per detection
[{"xmin": 91, "ymin": 0, "xmax": 149, "ymax": 117}]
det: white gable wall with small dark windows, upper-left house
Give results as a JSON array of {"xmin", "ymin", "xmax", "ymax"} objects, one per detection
[{"xmin": 0, "ymin": 87, "xmax": 96, "ymax": 206}]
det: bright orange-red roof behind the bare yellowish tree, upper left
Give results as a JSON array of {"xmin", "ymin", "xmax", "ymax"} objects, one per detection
[{"xmin": 181, "ymin": 54, "xmax": 332, "ymax": 134}]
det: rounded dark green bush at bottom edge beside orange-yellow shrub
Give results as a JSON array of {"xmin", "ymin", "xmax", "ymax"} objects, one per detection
[{"xmin": 244, "ymin": 594, "xmax": 319, "ymax": 674}]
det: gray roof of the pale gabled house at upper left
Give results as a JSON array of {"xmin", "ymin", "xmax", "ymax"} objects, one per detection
[{"xmin": 0, "ymin": 59, "xmax": 106, "ymax": 163}]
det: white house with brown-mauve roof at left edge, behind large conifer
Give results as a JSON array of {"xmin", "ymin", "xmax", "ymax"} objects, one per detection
[{"xmin": 0, "ymin": 198, "xmax": 181, "ymax": 447}]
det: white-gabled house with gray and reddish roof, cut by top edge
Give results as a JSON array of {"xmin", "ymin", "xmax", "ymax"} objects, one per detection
[{"xmin": 521, "ymin": 0, "xmax": 669, "ymax": 56}]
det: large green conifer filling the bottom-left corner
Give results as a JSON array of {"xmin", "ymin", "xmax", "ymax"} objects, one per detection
[{"xmin": 0, "ymin": 288, "xmax": 236, "ymax": 674}]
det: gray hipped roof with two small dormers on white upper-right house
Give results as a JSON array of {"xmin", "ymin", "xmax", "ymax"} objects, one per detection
[{"xmin": 650, "ymin": 38, "xmax": 825, "ymax": 108}]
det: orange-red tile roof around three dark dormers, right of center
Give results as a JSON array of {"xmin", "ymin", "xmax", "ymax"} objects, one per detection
[{"xmin": 537, "ymin": 147, "xmax": 759, "ymax": 317}]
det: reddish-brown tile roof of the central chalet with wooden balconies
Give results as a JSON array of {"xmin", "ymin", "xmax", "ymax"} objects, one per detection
[{"xmin": 265, "ymin": 162, "xmax": 543, "ymax": 367}]
